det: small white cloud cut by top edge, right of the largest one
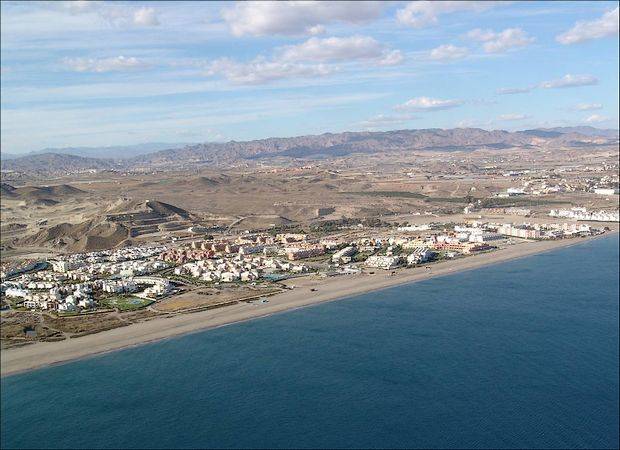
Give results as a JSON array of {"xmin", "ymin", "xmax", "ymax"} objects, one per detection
[{"xmin": 396, "ymin": 1, "xmax": 494, "ymax": 28}]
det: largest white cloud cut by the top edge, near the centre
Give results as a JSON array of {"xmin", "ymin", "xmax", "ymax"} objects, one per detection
[{"xmin": 222, "ymin": 1, "xmax": 384, "ymax": 36}]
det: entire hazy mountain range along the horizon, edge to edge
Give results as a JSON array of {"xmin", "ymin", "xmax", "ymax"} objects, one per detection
[{"xmin": 2, "ymin": 127, "xmax": 618, "ymax": 174}]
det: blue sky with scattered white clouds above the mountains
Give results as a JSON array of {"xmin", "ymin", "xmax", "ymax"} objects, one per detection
[{"xmin": 0, "ymin": 1, "xmax": 619, "ymax": 153}]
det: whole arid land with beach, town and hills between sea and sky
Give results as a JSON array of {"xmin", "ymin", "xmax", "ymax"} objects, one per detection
[{"xmin": 0, "ymin": 123, "xmax": 619, "ymax": 374}]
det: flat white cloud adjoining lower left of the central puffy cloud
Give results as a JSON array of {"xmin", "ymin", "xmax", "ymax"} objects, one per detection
[{"xmin": 207, "ymin": 57, "xmax": 334, "ymax": 84}]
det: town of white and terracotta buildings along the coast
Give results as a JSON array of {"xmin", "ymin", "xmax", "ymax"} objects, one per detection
[{"xmin": 0, "ymin": 216, "xmax": 617, "ymax": 326}]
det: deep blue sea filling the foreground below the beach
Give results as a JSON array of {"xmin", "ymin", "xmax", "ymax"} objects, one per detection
[{"xmin": 1, "ymin": 236, "xmax": 619, "ymax": 448}]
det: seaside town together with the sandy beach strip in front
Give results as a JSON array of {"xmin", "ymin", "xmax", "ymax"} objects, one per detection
[{"xmin": 0, "ymin": 209, "xmax": 617, "ymax": 374}]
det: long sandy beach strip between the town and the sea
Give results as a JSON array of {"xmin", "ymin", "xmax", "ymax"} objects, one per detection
[{"xmin": 0, "ymin": 231, "xmax": 617, "ymax": 378}]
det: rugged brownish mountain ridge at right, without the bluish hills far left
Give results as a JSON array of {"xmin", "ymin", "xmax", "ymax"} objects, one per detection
[{"xmin": 130, "ymin": 128, "xmax": 617, "ymax": 166}]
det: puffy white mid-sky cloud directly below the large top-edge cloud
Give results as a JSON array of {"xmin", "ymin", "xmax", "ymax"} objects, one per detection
[{"xmin": 281, "ymin": 36, "xmax": 403, "ymax": 65}]
